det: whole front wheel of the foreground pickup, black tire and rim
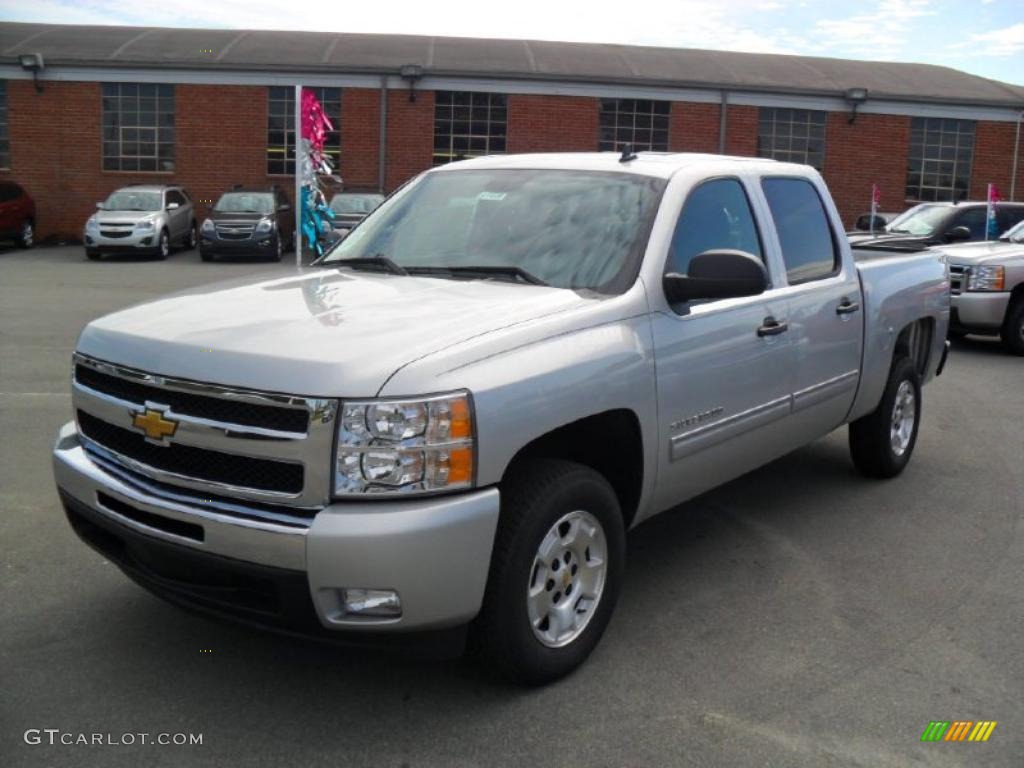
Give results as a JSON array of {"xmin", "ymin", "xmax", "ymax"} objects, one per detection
[{"xmin": 473, "ymin": 460, "xmax": 626, "ymax": 685}]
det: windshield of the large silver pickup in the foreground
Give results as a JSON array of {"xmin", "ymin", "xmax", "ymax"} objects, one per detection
[{"xmin": 321, "ymin": 169, "xmax": 665, "ymax": 293}]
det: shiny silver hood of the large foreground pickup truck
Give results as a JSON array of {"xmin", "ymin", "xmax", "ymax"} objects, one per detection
[{"xmin": 78, "ymin": 267, "xmax": 597, "ymax": 397}]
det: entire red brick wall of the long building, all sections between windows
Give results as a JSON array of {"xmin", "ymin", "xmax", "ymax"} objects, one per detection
[{"xmin": 0, "ymin": 80, "xmax": 1024, "ymax": 239}]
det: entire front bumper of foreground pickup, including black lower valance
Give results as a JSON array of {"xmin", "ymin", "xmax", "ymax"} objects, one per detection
[{"xmin": 53, "ymin": 423, "xmax": 499, "ymax": 639}]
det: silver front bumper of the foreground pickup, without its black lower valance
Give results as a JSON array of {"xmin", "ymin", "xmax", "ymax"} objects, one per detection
[{"xmin": 53, "ymin": 422, "xmax": 499, "ymax": 632}]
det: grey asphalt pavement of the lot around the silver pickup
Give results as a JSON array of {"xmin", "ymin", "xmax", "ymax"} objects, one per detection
[{"xmin": 0, "ymin": 248, "xmax": 1024, "ymax": 768}]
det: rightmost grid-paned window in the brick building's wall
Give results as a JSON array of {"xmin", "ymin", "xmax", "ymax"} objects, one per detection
[{"xmin": 906, "ymin": 118, "xmax": 975, "ymax": 202}]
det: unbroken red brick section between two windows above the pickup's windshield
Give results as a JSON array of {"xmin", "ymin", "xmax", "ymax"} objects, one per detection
[{"xmin": 506, "ymin": 94, "xmax": 599, "ymax": 153}]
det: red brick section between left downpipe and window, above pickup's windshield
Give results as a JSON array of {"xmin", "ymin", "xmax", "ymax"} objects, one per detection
[{"xmin": 385, "ymin": 90, "xmax": 434, "ymax": 191}]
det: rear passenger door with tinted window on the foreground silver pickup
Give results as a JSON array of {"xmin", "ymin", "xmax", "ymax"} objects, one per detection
[{"xmin": 761, "ymin": 176, "xmax": 864, "ymax": 444}]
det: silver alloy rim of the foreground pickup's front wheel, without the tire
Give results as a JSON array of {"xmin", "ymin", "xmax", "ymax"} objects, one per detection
[{"xmin": 526, "ymin": 510, "xmax": 608, "ymax": 648}]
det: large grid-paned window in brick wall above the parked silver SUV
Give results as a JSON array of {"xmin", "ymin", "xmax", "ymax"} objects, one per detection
[{"xmin": 101, "ymin": 83, "xmax": 174, "ymax": 171}]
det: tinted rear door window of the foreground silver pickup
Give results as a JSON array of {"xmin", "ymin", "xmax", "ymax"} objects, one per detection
[{"xmin": 761, "ymin": 178, "xmax": 839, "ymax": 285}]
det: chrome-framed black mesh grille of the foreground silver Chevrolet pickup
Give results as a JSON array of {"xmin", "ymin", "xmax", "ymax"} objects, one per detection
[{"xmin": 73, "ymin": 354, "xmax": 337, "ymax": 509}]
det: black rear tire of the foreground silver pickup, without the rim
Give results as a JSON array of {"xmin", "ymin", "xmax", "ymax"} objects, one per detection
[{"xmin": 850, "ymin": 356, "xmax": 921, "ymax": 478}]
